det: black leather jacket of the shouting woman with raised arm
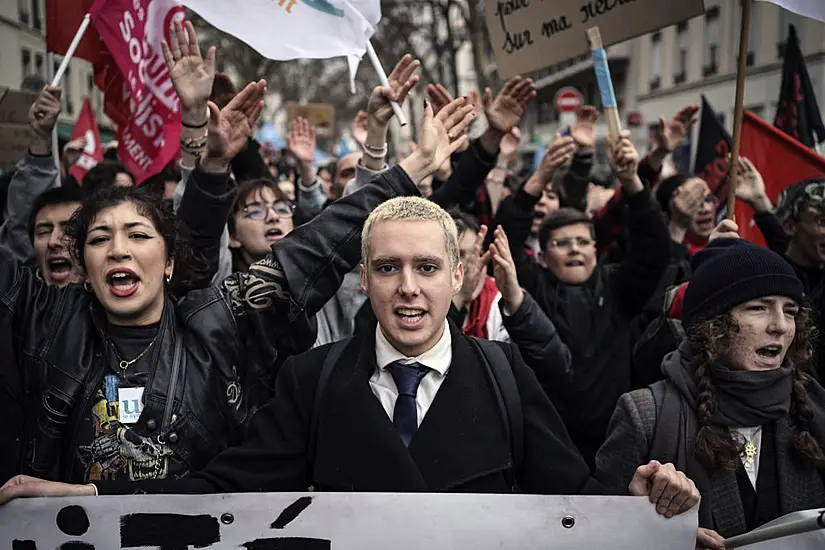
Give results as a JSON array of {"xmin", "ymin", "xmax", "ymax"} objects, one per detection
[{"xmin": 0, "ymin": 164, "xmax": 418, "ymax": 481}]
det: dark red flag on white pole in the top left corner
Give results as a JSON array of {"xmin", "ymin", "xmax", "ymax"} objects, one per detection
[{"xmin": 46, "ymin": 0, "xmax": 106, "ymax": 64}]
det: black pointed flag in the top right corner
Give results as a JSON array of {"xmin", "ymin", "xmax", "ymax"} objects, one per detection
[{"xmin": 773, "ymin": 25, "xmax": 825, "ymax": 147}]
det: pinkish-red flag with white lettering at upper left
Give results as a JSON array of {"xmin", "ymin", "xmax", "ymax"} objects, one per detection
[{"xmin": 91, "ymin": 0, "xmax": 184, "ymax": 184}]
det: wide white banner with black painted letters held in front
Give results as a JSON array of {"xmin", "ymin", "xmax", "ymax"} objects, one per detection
[{"xmin": 0, "ymin": 493, "xmax": 698, "ymax": 550}]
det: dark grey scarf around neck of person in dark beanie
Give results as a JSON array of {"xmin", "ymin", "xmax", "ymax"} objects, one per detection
[{"xmin": 663, "ymin": 343, "xmax": 793, "ymax": 428}]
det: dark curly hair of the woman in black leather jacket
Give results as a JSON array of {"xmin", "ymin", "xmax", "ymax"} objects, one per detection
[{"xmin": 64, "ymin": 187, "xmax": 200, "ymax": 285}]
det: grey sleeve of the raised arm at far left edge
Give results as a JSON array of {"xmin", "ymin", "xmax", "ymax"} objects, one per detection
[{"xmin": 0, "ymin": 153, "xmax": 58, "ymax": 264}]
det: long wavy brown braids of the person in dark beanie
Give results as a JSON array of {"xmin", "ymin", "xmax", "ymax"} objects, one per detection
[{"xmin": 688, "ymin": 308, "xmax": 825, "ymax": 470}]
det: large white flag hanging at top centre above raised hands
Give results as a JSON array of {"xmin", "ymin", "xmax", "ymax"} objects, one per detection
[{"xmin": 180, "ymin": 0, "xmax": 381, "ymax": 60}]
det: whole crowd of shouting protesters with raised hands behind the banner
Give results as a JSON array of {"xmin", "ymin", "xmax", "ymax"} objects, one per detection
[{"xmin": 0, "ymin": 19, "xmax": 825, "ymax": 548}]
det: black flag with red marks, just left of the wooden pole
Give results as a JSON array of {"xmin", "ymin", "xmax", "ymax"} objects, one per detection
[{"xmin": 693, "ymin": 95, "xmax": 731, "ymax": 213}]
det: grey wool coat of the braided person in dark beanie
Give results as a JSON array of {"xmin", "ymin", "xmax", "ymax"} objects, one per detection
[{"xmin": 596, "ymin": 382, "xmax": 825, "ymax": 538}]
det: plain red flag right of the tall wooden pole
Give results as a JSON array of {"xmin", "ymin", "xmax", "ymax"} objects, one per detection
[{"xmin": 736, "ymin": 111, "xmax": 825, "ymax": 246}]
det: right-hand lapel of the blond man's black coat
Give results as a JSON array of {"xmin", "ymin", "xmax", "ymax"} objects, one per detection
[{"xmin": 410, "ymin": 323, "xmax": 510, "ymax": 491}]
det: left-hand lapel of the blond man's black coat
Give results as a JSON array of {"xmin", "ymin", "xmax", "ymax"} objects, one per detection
[{"xmin": 314, "ymin": 331, "xmax": 427, "ymax": 492}]
